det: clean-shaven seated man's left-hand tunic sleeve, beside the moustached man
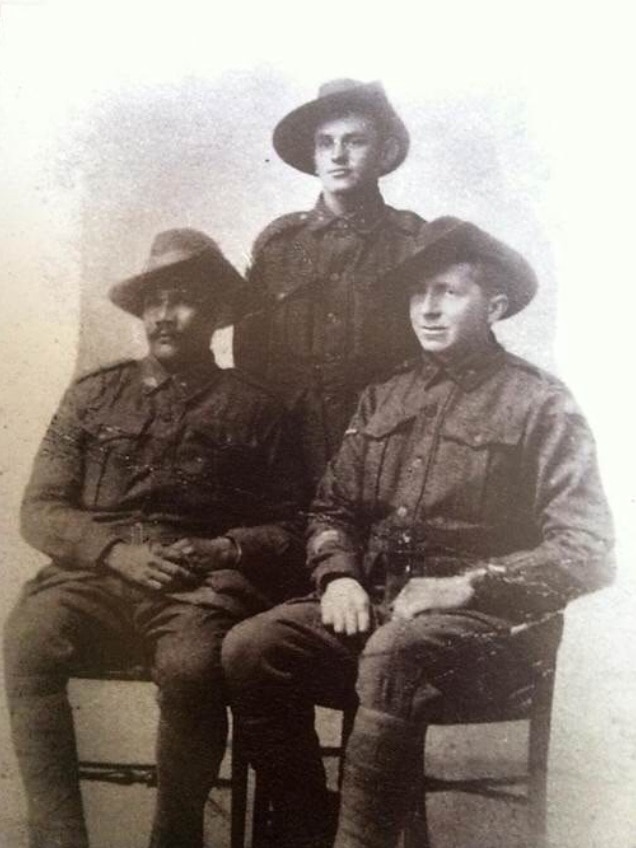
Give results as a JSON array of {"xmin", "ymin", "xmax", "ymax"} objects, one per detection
[{"xmin": 307, "ymin": 389, "xmax": 372, "ymax": 592}]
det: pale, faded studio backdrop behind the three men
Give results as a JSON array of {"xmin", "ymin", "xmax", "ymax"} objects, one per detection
[{"xmin": 0, "ymin": 3, "xmax": 636, "ymax": 848}]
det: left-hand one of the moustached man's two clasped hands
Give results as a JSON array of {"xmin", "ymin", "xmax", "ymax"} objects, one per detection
[{"xmin": 104, "ymin": 542, "xmax": 199, "ymax": 592}]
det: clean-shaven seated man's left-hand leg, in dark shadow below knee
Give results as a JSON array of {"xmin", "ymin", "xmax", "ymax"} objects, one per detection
[{"xmin": 223, "ymin": 600, "xmax": 359, "ymax": 848}]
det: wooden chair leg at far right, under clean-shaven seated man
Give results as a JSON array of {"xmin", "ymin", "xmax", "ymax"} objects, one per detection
[{"xmin": 528, "ymin": 674, "xmax": 554, "ymax": 848}]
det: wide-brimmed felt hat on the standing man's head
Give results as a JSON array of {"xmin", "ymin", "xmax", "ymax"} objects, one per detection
[{"xmin": 274, "ymin": 79, "xmax": 410, "ymax": 176}]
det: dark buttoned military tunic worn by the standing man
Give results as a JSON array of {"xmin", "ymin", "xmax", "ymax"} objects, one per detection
[{"xmin": 234, "ymin": 194, "xmax": 425, "ymax": 486}]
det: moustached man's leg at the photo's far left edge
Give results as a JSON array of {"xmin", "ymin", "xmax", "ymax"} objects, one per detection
[{"xmin": 4, "ymin": 568, "xmax": 133, "ymax": 848}]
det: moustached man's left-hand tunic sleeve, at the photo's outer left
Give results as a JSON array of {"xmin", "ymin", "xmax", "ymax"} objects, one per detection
[{"xmin": 21, "ymin": 380, "xmax": 126, "ymax": 569}]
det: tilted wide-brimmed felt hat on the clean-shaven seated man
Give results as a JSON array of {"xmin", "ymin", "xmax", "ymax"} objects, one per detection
[{"xmin": 388, "ymin": 216, "xmax": 538, "ymax": 318}]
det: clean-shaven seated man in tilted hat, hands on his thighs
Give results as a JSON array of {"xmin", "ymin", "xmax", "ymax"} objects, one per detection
[{"xmin": 224, "ymin": 218, "xmax": 613, "ymax": 848}]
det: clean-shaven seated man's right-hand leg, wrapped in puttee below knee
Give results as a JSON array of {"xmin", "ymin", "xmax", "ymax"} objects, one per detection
[{"xmin": 335, "ymin": 613, "xmax": 520, "ymax": 848}]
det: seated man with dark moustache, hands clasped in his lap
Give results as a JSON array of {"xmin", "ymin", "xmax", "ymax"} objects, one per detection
[{"xmin": 5, "ymin": 229, "xmax": 302, "ymax": 848}]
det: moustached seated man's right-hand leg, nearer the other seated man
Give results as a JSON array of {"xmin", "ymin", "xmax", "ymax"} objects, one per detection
[{"xmin": 141, "ymin": 603, "xmax": 243, "ymax": 848}]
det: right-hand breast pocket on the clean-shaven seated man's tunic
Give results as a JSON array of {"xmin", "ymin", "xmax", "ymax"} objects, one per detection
[{"xmin": 438, "ymin": 422, "xmax": 522, "ymax": 524}]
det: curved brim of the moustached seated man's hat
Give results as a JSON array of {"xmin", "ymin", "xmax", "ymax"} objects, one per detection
[{"xmin": 108, "ymin": 252, "xmax": 247, "ymax": 327}]
